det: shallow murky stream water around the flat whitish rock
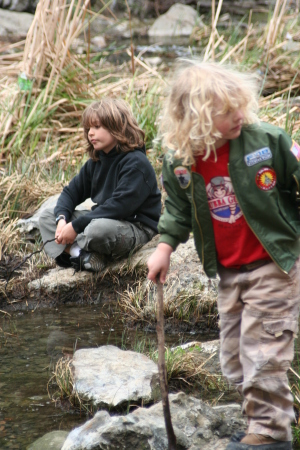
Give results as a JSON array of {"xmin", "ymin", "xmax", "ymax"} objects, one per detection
[{"xmin": 0, "ymin": 304, "xmax": 218, "ymax": 450}]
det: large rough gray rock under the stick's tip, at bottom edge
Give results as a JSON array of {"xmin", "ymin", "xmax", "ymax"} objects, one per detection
[{"xmin": 62, "ymin": 392, "xmax": 246, "ymax": 450}]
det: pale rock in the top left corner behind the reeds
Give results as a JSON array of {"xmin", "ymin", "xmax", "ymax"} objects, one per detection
[{"xmin": 0, "ymin": 9, "xmax": 34, "ymax": 40}]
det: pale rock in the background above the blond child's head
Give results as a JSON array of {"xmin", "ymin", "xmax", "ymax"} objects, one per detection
[{"xmin": 148, "ymin": 3, "xmax": 198, "ymax": 37}]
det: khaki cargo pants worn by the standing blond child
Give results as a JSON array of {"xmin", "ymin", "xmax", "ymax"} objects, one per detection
[{"xmin": 218, "ymin": 260, "xmax": 300, "ymax": 441}]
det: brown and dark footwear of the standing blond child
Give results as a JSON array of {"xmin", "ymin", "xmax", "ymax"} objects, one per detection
[{"xmin": 226, "ymin": 433, "xmax": 292, "ymax": 450}]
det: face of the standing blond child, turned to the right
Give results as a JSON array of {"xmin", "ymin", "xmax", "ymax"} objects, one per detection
[{"xmin": 213, "ymin": 109, "xmax": 244, "ymax": 148}]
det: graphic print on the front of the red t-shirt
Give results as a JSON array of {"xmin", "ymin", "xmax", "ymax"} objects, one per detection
[{"xmin": 206, "ymin": 177, "xmax": 243, "ymax": 223}]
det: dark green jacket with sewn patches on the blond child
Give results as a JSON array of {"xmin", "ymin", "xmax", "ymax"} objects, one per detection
[{"xmin": 158, "ymin": 122, "xmax": 300, "ymax": 277}]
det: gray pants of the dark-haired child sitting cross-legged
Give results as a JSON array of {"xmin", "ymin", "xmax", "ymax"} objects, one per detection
[{"xmin": 39, "ymin": 208, "xmax": 156, "ymax": 259}]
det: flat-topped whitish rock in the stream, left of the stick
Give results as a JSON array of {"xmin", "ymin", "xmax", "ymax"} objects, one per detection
[{"xmin": 72, "ymin": 345, "xmax": 159, "ymax": 407}]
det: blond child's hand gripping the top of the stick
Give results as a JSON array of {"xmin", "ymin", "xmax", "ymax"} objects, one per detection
[{"xmin": 147, "ymin": 242, "xmax": 173, "ymax": 283}]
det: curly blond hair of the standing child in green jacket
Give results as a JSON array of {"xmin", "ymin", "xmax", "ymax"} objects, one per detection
[{"xmin": 160, "ymin": 60, "xmax": 258, "ymax": 165}]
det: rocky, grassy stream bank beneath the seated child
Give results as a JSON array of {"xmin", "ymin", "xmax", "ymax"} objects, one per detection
[{"xmin": 0, "ymin": 236, "xmax": 218, "ymax": 333}]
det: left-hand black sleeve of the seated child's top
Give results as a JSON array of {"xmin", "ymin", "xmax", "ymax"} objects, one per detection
[{"xmin": 54, "ymin": 160, "xmax": 92, "ymax": 222}]
